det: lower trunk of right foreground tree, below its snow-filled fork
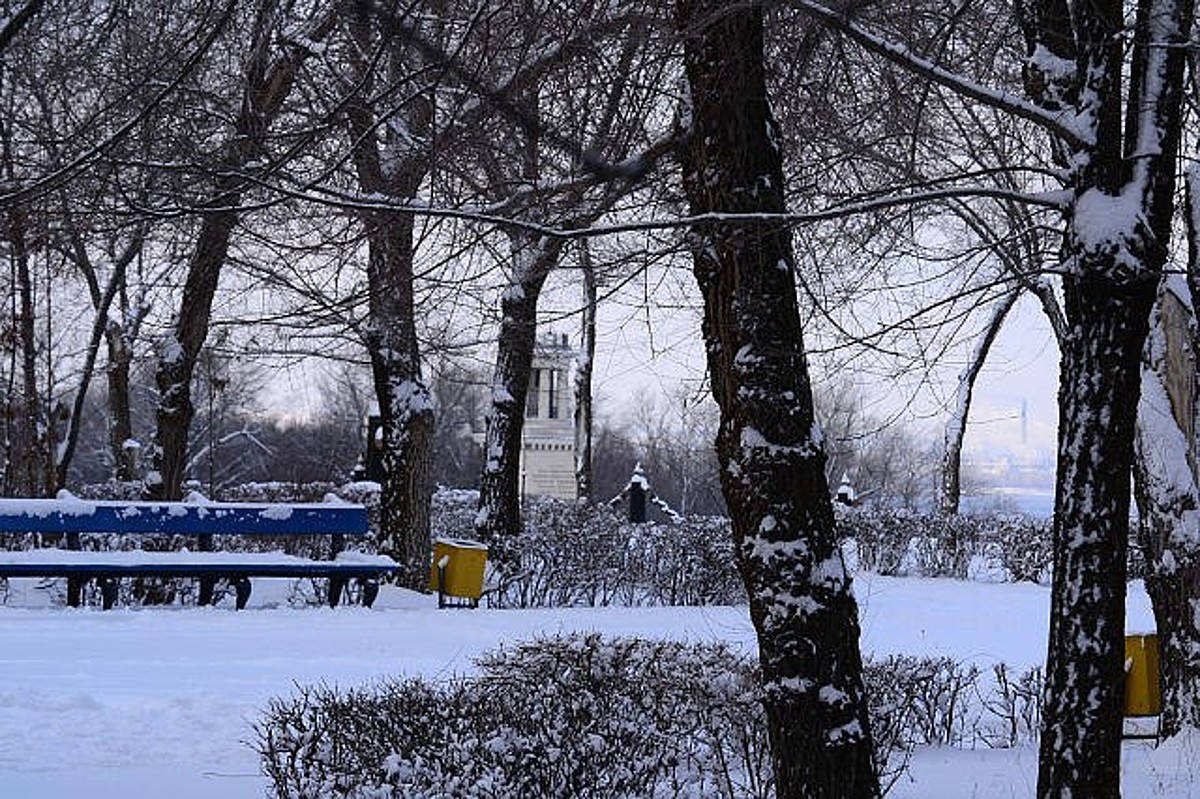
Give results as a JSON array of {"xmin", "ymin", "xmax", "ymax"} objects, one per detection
[{"xmin": 1038, "ymin": 265, "xmax": 1154, "ymax": 798}]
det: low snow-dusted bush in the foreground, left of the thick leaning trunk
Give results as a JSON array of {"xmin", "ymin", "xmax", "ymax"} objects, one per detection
[{"xmin": 257, "ymin": 635, "xmax": 772, "ymax": 799}]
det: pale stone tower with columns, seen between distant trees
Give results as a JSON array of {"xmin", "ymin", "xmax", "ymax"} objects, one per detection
[{"xmin": 521, "ymin": 334, "xmax": 576, "ymax": 499}]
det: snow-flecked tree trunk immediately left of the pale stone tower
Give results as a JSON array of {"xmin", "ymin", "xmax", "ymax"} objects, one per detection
[{"xmin": 475, "ymin": 233, "xmax": 563, "ymax": 552}]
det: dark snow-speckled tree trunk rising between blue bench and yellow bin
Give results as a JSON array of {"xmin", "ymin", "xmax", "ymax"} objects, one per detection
[{"xmin": 347, "ymin": 9, "xmax": 436, "ymax": 590}]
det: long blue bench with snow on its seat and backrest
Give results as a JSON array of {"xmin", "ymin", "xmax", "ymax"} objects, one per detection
[{"xmin": 0, "ymin": 495, "xmax": 400, "ymax": 609}]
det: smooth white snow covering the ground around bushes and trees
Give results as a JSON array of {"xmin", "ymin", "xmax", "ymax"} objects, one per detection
[{"xmin": 0, "ymin": 575, "xmax": 1200, "ymax": 799}]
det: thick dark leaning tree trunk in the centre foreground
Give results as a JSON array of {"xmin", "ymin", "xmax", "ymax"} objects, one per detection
[{"xmin": 677, "ymin": 0, "xmax": 880, "ymax": 799}]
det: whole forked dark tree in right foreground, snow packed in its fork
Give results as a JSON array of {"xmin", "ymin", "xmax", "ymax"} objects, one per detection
[{"xmin": 1018, "ymin": 0, "xmax": 1194, "ymax": 798}]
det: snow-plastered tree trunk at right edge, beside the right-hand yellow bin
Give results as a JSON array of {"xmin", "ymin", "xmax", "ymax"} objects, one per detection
[{"xmin": 1135, "ymin": 279, "xmax": 1200, "ymax": 735}]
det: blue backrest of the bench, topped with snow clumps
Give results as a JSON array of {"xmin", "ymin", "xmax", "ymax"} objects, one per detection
[{"xmin": 0, "ymin": 498, "xmax": 368, "ymax": 535}]
